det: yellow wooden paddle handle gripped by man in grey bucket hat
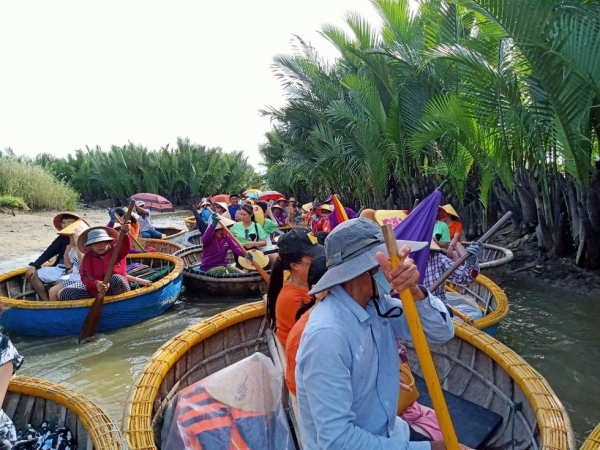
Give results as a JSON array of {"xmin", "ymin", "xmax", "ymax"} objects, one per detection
[{"xmin": 381, "ymin": 224, "xmax": 459, "ymax": 450}]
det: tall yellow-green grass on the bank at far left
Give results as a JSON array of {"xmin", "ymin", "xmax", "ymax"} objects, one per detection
[{"xmin": 0, "ymin": 157, "xmax": 79, "ymax": 211}]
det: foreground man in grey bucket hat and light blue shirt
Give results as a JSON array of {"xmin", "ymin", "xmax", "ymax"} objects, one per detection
[{"xmin": 296, "ymin": 218, "xmax": 454, "ymax": 450}]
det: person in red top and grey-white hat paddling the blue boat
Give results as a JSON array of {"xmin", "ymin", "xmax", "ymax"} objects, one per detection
[{"xmin": 60, "ymin": 222, "xmax": 131, "ymax": 300}]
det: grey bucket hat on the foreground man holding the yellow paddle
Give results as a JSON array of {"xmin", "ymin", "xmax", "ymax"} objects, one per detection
[{"xmin": 308, "ymin": 217, "xmax": 429, "ymax": 295}]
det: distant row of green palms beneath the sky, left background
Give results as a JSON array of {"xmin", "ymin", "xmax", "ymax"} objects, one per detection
[{"xmin": 35, "ymin": 138, "xmax": 264, "ymax": 204}]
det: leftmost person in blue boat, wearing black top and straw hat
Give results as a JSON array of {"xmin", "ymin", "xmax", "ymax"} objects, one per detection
[{"xmin": 25, "ymin": 212, "xmax": 87, "ymax": 301}]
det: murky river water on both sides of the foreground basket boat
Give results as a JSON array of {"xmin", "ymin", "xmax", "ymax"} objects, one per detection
[{"xmin": 2, "ymin": 219, "xmax": 600, "ymax": 442}]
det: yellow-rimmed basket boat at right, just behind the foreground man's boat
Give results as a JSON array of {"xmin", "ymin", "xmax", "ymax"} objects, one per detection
[{"xmin": 446, "ymin": 274, "xmax": 509, "ymax": 336}]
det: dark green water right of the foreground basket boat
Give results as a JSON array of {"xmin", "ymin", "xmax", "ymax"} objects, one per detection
[{"xmin": 497, "ymin": 277, "xmax": 600, "ymax": 443}]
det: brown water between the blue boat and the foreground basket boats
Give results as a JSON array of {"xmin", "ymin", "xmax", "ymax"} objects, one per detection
[{"xmin": 10, "ymin": 297, "xmax": 244, "ymax": 422}]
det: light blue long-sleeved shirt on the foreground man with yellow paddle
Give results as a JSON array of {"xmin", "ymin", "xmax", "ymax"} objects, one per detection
[{"xmin": 296, "ymin": 285, "xmax": 454, "ymax": 450}]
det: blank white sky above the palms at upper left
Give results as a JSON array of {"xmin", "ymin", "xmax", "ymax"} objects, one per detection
[{"xmin": 0, "ymin": 0, "xmax": 378, "ymax": 166}]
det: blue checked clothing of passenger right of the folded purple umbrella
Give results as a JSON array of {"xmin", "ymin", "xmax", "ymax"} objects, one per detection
[{"xmin": 423, "ymin": 241, "xmax": 483, "ymax": 303}]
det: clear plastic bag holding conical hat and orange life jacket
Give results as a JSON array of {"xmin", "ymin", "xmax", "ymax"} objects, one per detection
[{"xmin": 162, "ymin": 353, "xmax": 293, "ymax": 450}]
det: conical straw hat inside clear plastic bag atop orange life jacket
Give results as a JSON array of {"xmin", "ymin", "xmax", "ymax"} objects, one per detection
[{"xmin": 204, "ymin": 352, "xmax": 282, "ymax": 412}]
